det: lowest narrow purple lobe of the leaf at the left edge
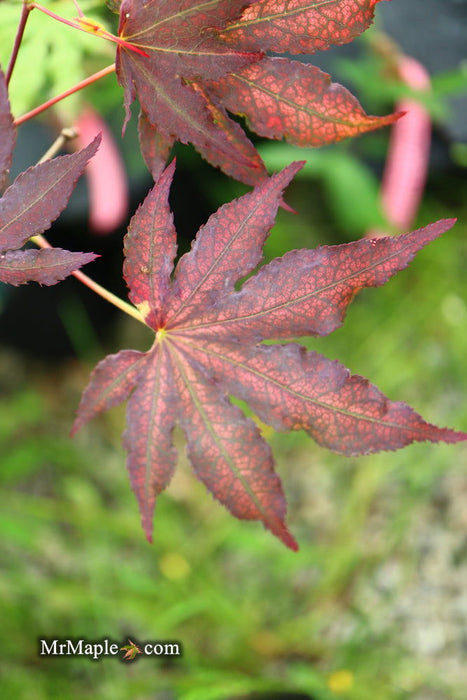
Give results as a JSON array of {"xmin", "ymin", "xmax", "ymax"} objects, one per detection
[{"xmin": 0, "ymin": 248, "xmax": 97, "ymax": 286}]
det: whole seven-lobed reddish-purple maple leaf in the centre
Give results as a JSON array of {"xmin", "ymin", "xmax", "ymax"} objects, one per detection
[{"xmin": 72, "ymin": 163, "xmax": 467, "ymax": 549}]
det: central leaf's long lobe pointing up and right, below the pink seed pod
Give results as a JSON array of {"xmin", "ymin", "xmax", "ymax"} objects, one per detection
[{"xmin": 189, "ymin": 219, "xmax": 455, "ymax": 340}]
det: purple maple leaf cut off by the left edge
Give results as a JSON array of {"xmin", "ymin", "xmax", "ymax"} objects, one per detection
[{"xmin": 0, "ymin": 68, "xmax": 100, "ymax": 286}]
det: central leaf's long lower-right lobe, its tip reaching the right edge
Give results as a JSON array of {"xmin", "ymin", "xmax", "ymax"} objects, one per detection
[{"xmin": 185, "ymin": 337, "xmax": 467, "ymax": 455}]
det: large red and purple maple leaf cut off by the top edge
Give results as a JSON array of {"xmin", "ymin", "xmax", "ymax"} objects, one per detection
[{"xmin": 117, "ymin": 0, "xmax": 398, "ymax": 185}]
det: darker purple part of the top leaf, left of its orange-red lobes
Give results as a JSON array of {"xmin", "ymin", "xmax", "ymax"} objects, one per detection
[{"xmin": 117, "ymin": 0, "xmax": 266, "ymax": 184}]
